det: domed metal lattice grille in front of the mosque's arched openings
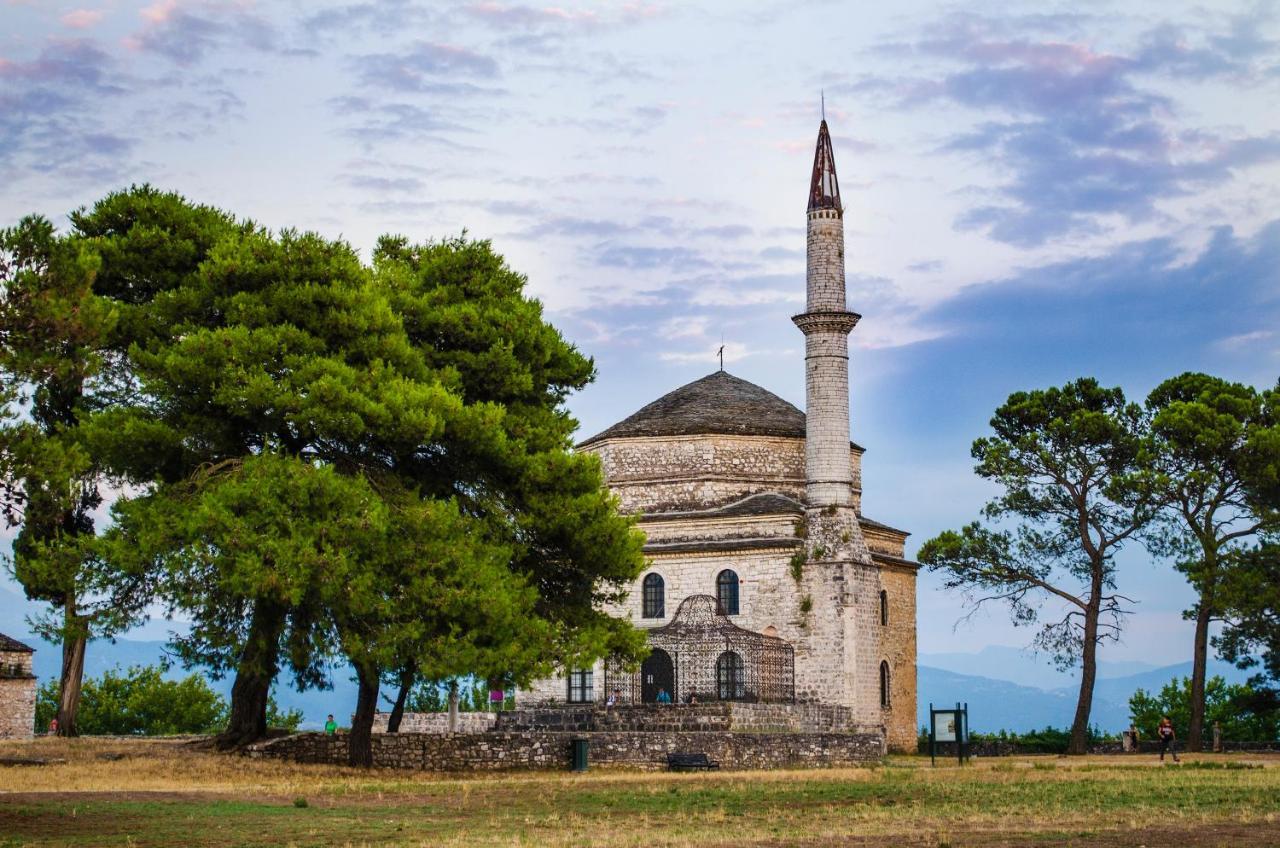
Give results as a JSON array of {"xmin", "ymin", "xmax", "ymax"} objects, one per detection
[{"xmin": 600, "ymin": 594, "xmax": 795, "ymax": 703}]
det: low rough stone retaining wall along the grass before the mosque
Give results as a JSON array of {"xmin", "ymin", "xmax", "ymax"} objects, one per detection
[{"xmin": 253, "ymin": 731, "xmax": 884, "ymax": 771}]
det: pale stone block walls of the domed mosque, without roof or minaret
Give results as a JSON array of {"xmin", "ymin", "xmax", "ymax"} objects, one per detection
[{"xmin": 518, "ymin": 436, "xmax": 915, "ymax": 749}]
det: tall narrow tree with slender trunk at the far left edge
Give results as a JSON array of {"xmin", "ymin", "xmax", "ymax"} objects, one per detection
[{"xmin": 0, "ymin": 216, "xmax": 148, "ymax": 734}]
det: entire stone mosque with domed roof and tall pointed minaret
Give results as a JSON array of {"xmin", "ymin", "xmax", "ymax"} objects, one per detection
[{"xmin": 521, "ymin": 119, "xmax": 919, "ymax": 749}]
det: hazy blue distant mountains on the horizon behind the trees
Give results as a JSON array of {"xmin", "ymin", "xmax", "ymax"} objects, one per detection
[{"xmin": 0, "ymin": 588, "xmax": 1249, "ymax": 733}]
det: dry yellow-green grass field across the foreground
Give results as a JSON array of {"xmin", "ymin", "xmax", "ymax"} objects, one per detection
[{"xmin": 0, "ymin": 739, "xmax": 1280, "ymax": 848}]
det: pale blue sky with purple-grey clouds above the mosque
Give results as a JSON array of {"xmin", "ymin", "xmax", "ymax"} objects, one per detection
[{"xmin": 0, "ymin": 0, "xmax": 1280, "ymax": 662}]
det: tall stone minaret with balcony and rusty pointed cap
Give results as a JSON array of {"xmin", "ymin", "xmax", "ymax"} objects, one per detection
[{"xmin": 792, "ymin": 119, "xmax": 884, "ymax": 726}]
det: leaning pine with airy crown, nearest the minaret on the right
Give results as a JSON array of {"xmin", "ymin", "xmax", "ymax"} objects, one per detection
[{"xmin": 919, "ymin": 379, "xmax": 1156, "ymax": 752}]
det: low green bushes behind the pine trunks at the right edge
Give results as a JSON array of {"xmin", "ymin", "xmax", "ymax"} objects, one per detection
[{"xmin": 1129, "ymin": 676, "xmax": 1280, "ymax": 742}]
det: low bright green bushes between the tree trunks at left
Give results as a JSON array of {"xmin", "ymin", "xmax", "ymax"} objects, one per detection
[{"xmin": 36, "ymin": 666, "xmax": 227, "ymax": 735}]
